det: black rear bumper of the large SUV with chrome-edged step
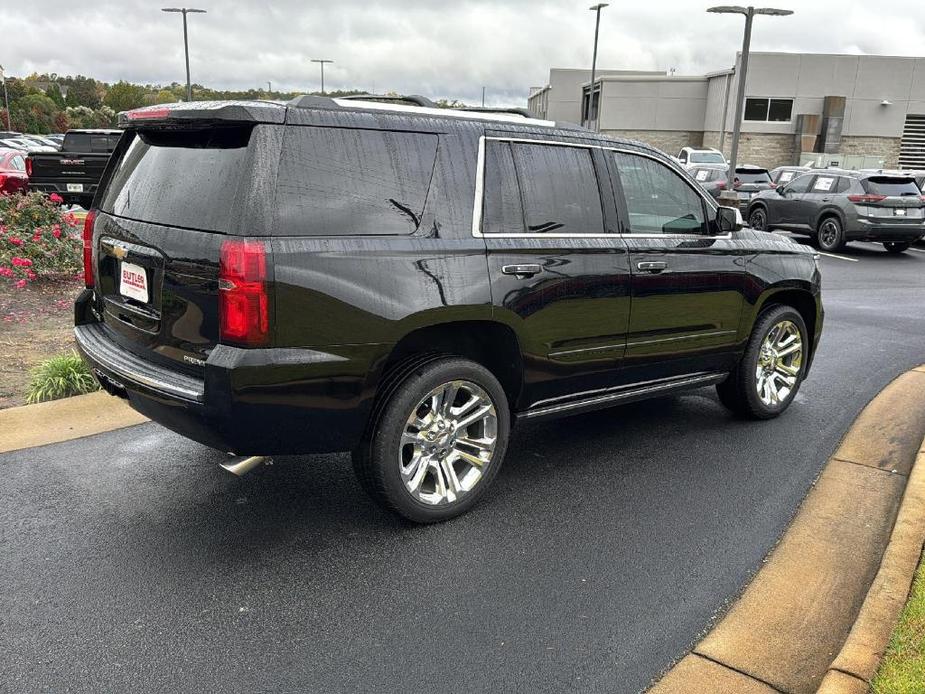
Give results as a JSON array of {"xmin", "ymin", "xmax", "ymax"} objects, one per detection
[{"xmin": 74, "ymin": 290, "xmax": 373, "ymax": 455}]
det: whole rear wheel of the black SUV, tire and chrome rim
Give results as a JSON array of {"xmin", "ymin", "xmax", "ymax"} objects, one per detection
[{"xmin": 353, "ymin": 357, "xmax": 510, "ymax": 523}]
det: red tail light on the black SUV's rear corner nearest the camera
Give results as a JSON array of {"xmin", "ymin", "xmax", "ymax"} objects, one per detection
[{"xmin": 218, "ymin": 239, "xmax": 270, "ymax": 346}]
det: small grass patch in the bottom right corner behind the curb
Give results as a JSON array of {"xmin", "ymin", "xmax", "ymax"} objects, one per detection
[{"xmin": 871, "ymin": 555, "xmax": 925, "ymax": 694}]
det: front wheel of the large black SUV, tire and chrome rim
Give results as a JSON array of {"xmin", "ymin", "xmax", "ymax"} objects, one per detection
[{"xmin": 716, "ymin": 306, "xmax": 808, "ymax": 419}]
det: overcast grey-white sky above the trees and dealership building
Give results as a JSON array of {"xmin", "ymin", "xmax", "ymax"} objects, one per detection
[{"xmin": 0, "ymin": 0, "xmax": 925, "ymax": 105}]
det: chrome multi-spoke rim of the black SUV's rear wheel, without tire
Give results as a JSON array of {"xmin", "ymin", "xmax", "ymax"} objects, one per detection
[{"xmin": 398, "ymin": 381, "xmax": 498, "ymax": 506}]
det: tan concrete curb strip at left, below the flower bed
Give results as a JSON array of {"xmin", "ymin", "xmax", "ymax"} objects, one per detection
[{"xmin": 0, "ymin": 391, "xmax": 148, "ymax": 453}]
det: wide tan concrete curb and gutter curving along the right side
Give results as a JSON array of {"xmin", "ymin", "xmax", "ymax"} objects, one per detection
[{"xmin": 650, "ymin": 366, "xmax": 925, "ymax": 694}]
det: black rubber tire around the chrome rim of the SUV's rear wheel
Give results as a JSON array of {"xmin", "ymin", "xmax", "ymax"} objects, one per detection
[{"xmin": 360, "ymin": 358, "xmax": 511, "ymax": 523}]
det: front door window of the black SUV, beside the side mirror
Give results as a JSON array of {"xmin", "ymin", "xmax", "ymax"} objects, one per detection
[{"xmin": 614, "ymin": 152, "xmax": 706, "ymax": 234}]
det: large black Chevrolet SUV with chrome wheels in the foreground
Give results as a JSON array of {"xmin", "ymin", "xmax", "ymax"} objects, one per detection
[{"xmin": 76, "ymin": 97, "xmax": 823, "ymax": 522}]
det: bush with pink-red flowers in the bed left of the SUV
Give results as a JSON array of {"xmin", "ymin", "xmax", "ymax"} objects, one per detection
[{"xmin": 0, "ymin": 193, "xmax": 83, "ymax": 288}]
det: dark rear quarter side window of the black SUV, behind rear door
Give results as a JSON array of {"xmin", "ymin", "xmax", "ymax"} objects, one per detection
[{"xmin": 276, "ymin": 127, "xmax": 437, "ymax": 236}]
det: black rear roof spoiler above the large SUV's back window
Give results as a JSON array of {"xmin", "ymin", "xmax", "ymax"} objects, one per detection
[{"xmin": 119, "ymin": 101, "xmax": 286, "ymax": 128}]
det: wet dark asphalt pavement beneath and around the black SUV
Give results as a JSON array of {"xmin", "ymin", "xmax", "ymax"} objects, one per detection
[{"xmin": 0, "ymin": 237, "xmax": 925, "ymax": 692}]
